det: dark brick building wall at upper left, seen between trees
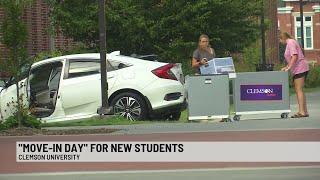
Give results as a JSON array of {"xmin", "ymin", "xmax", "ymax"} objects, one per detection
[{"xmin": 0, "ymin": 0, "xmax": 73, "ymax": 58}]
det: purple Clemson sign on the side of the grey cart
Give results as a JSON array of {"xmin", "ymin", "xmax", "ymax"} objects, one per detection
[{"xmin": 240, "ymin": 84, "xmax": 282, "ymax": 101}]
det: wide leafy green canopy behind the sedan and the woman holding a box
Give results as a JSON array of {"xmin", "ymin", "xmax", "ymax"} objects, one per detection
[{"xmin": 50, "ymin": 0, "xmax": 261, "ymax": 72}]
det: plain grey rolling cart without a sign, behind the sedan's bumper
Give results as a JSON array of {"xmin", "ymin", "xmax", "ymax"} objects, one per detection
[{"xmin": 186, "ymin": 74, "xmax": 230, "ymax": 121}]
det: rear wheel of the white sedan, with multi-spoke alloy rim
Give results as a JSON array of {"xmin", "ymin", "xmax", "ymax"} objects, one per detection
[{"xmin": 110, "ymin": 92, "xmax": 148, "ymax": 121}]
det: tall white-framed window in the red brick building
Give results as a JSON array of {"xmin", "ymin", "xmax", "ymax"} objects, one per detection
[{"xmin": 295, "ymin": 16, "xmax": 313, "ymax": 49}]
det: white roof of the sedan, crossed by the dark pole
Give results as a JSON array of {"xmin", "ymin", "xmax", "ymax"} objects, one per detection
[{"xmin": 32, "ymin": 53, "xmax": 164, "ymax": 67}]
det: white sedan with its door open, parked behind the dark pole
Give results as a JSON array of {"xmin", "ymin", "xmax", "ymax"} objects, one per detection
[{"xmin": 0, "ymin": 52, "xmax": 185, "ymax": 122}]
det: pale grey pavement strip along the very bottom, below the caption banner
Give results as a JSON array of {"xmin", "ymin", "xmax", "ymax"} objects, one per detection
[{"xmin": 0, "ymin": 166, "xmax": 320, "ymax": 180}]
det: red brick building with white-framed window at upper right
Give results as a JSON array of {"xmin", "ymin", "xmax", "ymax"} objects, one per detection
[{"xmin": 278, "ymin": 0, "xmax": 320, "ymax": 64}]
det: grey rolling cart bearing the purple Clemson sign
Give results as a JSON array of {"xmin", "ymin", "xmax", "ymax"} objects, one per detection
[{"xmin": 233, "ymin": 71, "xmax": 290, "ymax": 121}]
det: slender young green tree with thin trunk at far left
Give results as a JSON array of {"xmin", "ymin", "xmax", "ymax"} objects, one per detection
[{"xmin": 0, "ymin": 0, "xmax": 32, "ymax": 127}]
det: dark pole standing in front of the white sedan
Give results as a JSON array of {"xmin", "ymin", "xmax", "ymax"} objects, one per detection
[{"xmin": 98, "ymin": 0, "xmax": 112, "ymax": 117}]
